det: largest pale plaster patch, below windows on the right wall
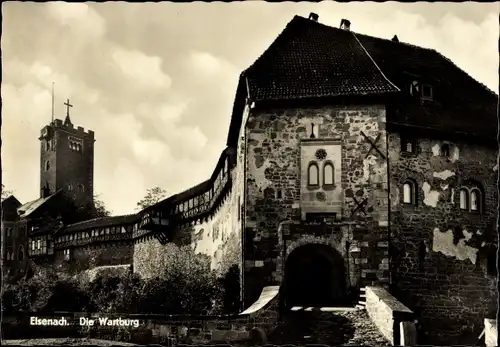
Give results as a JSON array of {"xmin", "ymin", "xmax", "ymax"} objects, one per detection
[{"xmin": 432, "ymin": 228, "xmax": 478, "ymax": 264}]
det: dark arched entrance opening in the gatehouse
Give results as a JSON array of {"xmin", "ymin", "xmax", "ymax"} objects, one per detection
[{"xmin": 282, "ymin": 244, "xmax": 348, "ymax": 309}]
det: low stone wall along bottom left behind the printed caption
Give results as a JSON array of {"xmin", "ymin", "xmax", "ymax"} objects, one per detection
[{"xmin": 2, "ymin": 301, "xmax": 278, "ymax": 345}]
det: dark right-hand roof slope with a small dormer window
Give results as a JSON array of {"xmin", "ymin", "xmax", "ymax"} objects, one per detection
[{"xmin": 356, "ymin": 34, "xmax": 498, "ymax": 139}]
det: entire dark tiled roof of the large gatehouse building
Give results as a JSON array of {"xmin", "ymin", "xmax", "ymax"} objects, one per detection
[{"xmin": 227, "ymin": 16, "xmax": 498, "ymax": 147}]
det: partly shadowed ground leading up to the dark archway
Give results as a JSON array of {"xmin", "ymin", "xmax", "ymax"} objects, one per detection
[{"xmin": 270, "ymin": 310, "xmax": 390, "ymax": 347}]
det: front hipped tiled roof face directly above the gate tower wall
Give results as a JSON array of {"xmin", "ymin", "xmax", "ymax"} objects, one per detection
[{"xmin": 245, "ymin": 16, "xmax": 398, "ymax": 101}]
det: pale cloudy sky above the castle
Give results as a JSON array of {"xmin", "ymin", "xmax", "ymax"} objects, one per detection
[{"xmin": 1, "ymin": 1, "xmax": 500, "ymax": 215}]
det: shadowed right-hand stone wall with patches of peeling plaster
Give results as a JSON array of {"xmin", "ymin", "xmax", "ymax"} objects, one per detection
[{"xmin": 389, "ymin": 133, "xmax": 498, "ymax": 344}]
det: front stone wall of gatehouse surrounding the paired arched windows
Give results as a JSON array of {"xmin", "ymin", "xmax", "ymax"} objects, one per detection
[{"xmin": 244, "ymin": 106, "xmax": 388, "ymax": 304}]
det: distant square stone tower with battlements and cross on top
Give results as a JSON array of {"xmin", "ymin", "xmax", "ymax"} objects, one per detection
[{"xmin": 39, "ymin": 100, "xmax": 95, "ymax": 211}]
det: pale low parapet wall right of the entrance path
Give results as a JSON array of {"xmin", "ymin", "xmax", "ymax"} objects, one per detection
[{"xmin": 366, "ymin": 287, "xmax": 416, "ymax": 345}]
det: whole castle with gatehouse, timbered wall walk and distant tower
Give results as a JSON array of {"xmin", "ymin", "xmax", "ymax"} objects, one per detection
[{"xmin": 2, "ymin": 13, "xmax": 498, "ymax": 341}]
